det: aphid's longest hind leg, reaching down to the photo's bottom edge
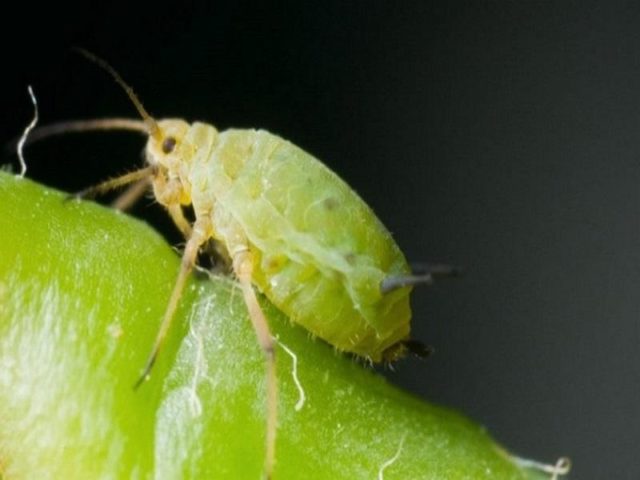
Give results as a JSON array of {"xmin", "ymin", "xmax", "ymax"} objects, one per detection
[{"xmin": 233, "ymin": 249, "xmax": 278, "ymax": 479}]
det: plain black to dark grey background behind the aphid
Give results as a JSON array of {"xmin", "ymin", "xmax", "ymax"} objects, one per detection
[{"xmin": 0, "ymin": 1, "xmax": 640, "ymax": 479}]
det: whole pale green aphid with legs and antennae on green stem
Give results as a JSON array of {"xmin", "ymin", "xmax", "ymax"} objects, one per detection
[{"xmin": 31, "ymin": 50, "xmax": 455, "ymax": 478}]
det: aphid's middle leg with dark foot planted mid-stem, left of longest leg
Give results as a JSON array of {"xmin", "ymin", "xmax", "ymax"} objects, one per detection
[{"xmin": 134, "ymin": 219, "xmax": 210, "ymax": 389}]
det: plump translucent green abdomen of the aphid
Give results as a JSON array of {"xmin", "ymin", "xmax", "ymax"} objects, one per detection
[{"xmin": 208, "ymin": 130, "xmax": 411, "ymax": 361}]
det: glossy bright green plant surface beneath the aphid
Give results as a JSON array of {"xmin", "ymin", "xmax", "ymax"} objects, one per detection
[{"xmin": 0, "ymin": 173, "xmax": 540, "ymax": 480}]
